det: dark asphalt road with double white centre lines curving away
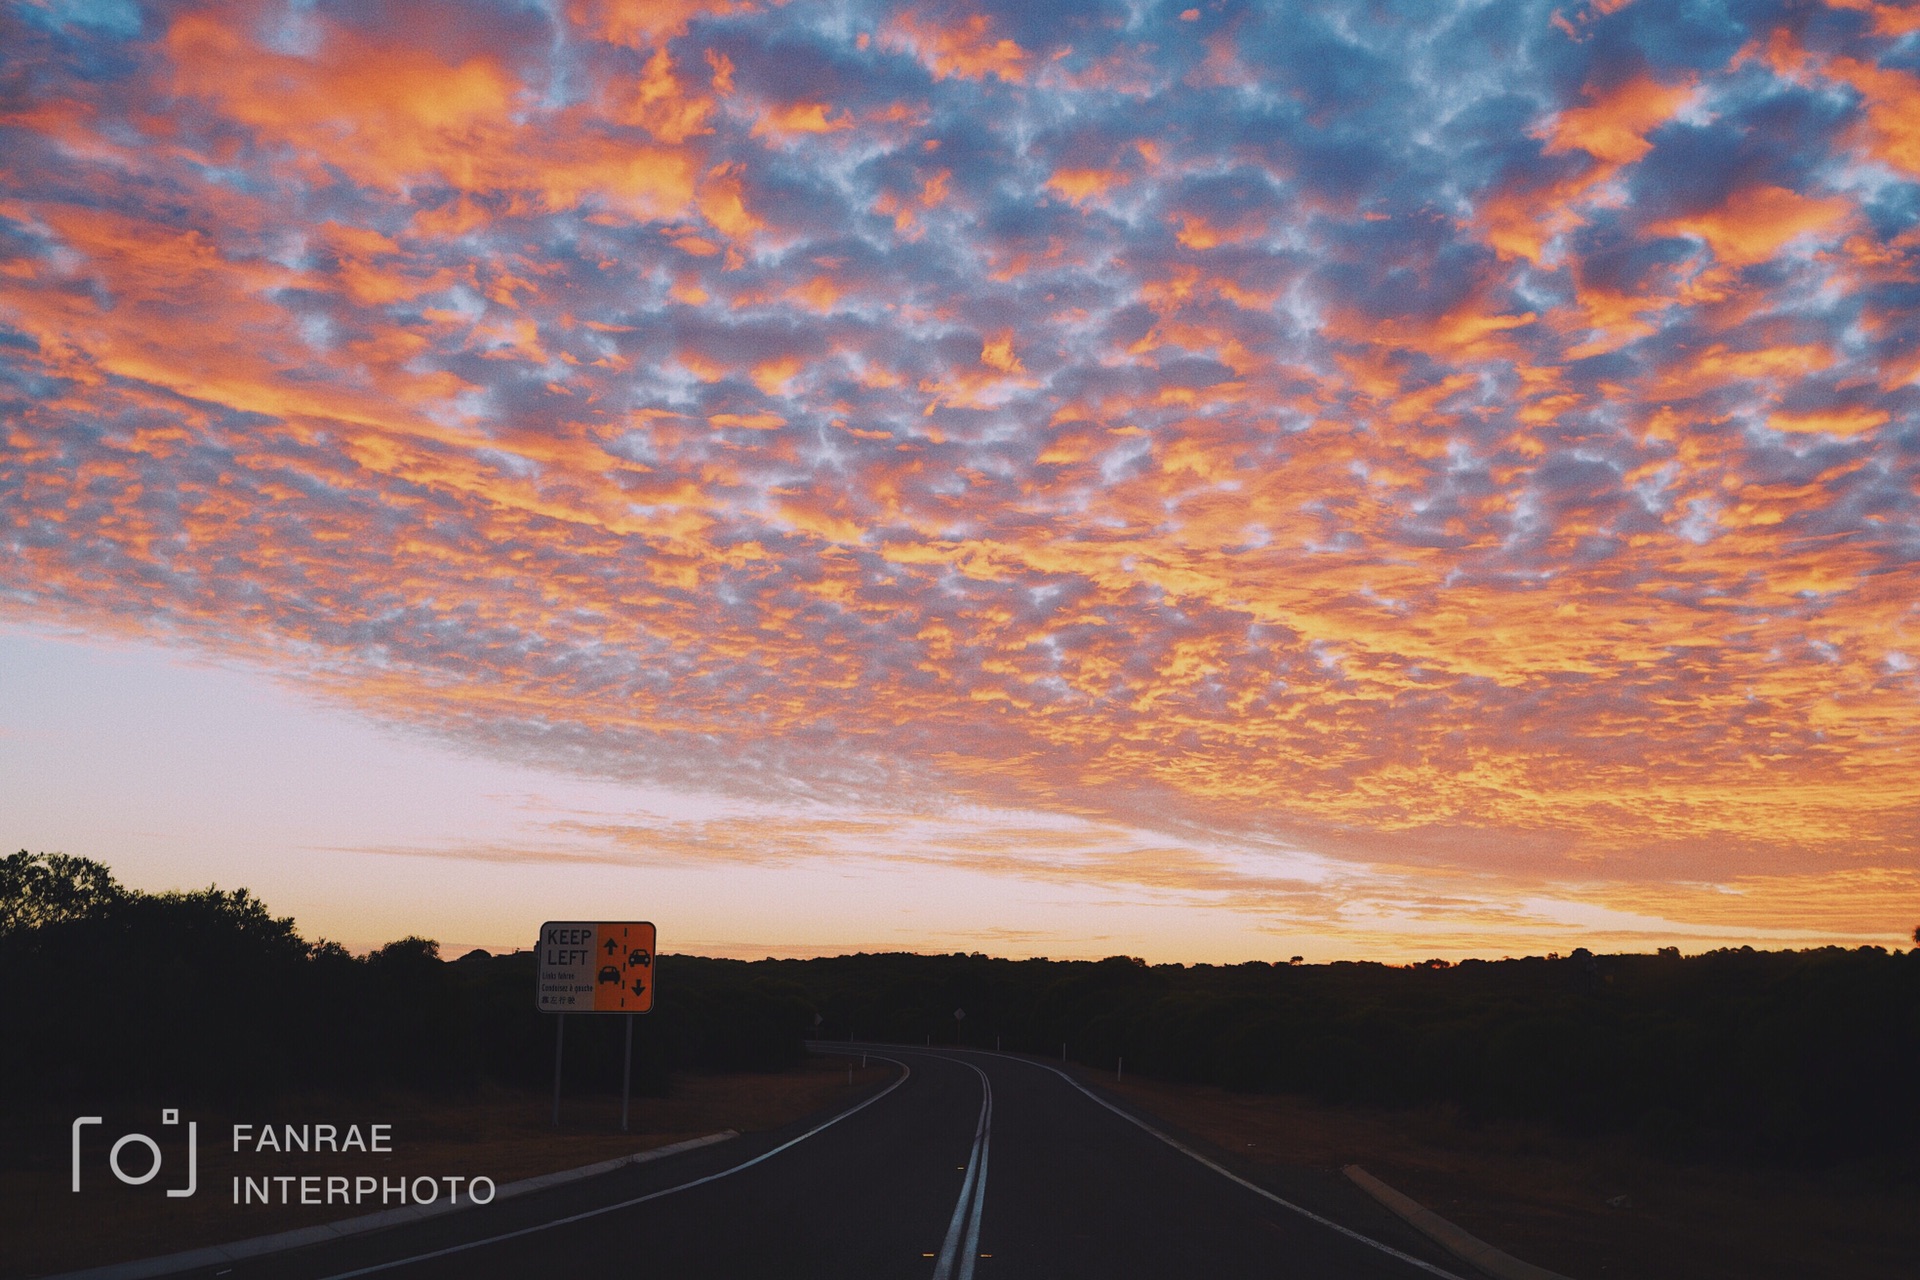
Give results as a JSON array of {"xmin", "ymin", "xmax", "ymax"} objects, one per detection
[{"xmin": 196, "ymin": 1046, "xmax": 1463, "ymax": 1280}]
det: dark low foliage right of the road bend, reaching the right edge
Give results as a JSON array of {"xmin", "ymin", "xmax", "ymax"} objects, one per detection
[{"xmin": 758, "ymin": 946, "xmax": 1920, "ymax": 1165}]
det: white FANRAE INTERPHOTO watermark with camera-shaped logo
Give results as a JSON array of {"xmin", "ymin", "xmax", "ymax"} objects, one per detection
[{"xmin": 71, "ymin": 1107, "xmax": 495, "ymax": 1207}]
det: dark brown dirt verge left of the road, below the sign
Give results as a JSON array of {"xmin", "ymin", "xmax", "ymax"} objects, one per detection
[{"xmin": 0, "ymin": 1057, "xmax": 891, "ymax": 1280}]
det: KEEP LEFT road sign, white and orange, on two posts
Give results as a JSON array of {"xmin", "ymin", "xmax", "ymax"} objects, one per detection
[{"xmin": 534, "ymin": 919, "xmax": 657, "ymax": 1132}]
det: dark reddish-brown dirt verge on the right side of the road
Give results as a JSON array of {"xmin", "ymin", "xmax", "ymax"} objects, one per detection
[{"xmin": 1087, "ymin": 1075, "xmax": 1920, "ymax": 1280}]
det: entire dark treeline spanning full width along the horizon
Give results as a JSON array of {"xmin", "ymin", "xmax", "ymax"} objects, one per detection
[{"xmin": 0, "ymin": 854, "xmax": 1920, "ymax": 1169}]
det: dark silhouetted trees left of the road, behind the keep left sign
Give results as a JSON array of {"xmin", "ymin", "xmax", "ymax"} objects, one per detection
[{"xmin": 0, "ymin": 850, "xmax": 814, "ymax": 1102}]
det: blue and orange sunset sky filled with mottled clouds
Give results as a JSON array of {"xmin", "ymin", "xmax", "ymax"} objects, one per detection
[{"xmin": 0, "ymin": 0, "xmax": 1920, "ymax": 961}]
